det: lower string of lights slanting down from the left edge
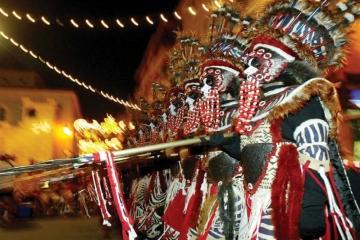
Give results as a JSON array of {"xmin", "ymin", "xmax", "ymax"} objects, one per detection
[{"xmin": 0, "ymin": 31, "xmax": 141, "ymax": 111}]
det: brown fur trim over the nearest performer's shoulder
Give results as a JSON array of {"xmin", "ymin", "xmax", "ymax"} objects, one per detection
[{"xmin": 268, "ymin": 78, "xmax": 341, "ymax": 138}]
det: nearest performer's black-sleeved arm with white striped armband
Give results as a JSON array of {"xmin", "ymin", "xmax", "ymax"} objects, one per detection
[{"xmin": 282, "ymin": 98, "xmax": 329, "ymax": 239}]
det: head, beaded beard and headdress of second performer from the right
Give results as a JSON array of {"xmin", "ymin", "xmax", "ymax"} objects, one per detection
[{"xmin": 195, "ymin": 7, "xmax": 245, "ymax": 132}]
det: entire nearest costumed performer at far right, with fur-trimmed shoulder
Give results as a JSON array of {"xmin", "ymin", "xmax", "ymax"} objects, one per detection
[{"xmin": 236, "ymin": 0, "xmax": 360, "ymax": 239}]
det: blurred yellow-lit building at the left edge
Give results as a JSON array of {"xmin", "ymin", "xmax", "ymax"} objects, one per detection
[{"xmin": 0, "ymin": 70, "xmax": 81, "ymax": 165}]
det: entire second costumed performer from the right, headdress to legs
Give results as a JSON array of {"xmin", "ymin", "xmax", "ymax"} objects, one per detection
[{"xmin": 187, "ymin": 7, "xmax": 245, "ymax": 240}]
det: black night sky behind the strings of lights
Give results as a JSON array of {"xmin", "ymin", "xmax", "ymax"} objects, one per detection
[{"xmin": 0, "ymin": 0, "xmax": 178, "ymax": 120}]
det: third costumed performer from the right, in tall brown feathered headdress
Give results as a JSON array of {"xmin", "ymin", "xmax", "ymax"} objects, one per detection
[{"xmin": 160, "ymin": 32, "xmax": 204, "ymax": 239}]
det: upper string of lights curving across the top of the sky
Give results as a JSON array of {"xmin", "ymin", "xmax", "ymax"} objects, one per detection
[{"xmin": 0, "ymin": 0, "xmax": 219, "ymax": 30}]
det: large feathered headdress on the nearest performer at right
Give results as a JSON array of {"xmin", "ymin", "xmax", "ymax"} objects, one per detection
[{"xmin": 249, "ymin": 0, "xmax": 360, "ymax": 70}]
